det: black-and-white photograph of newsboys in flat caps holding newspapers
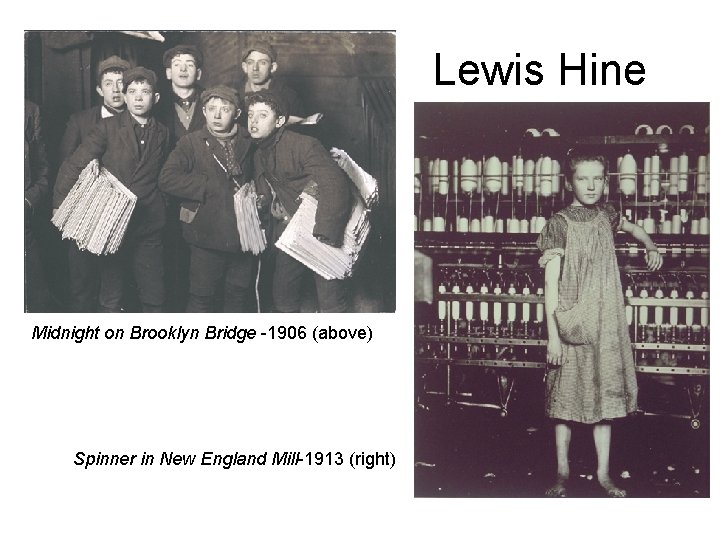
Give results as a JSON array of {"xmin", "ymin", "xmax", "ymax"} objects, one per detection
[{"xmin": 24, "ymin": 30, "xmax": 396, "ymax": 313}]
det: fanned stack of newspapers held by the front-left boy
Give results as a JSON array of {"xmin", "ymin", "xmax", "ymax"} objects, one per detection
[{"xmin": 52, "ymin": 160, "xmax": 137, "ymax": 255}]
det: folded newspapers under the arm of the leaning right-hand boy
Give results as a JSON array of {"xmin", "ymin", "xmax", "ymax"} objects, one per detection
[{"xmin": 275, "ymin": 148, "xmax": 378, "ymax": 279}]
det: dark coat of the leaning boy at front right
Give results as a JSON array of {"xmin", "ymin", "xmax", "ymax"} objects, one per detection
[{"xmin": 255, "ymin": 128, "xmax": 352, "ymax": 246}]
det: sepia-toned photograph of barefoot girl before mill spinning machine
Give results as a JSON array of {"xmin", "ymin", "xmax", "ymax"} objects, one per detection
[{"xmin": 413, "ymin": 102, "xmax": 711, "ymax": 498}]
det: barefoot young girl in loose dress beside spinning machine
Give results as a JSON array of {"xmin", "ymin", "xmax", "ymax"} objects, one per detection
[{"xmin": 537, "ymin": 154, "xmax": 662, "ymax": 497}]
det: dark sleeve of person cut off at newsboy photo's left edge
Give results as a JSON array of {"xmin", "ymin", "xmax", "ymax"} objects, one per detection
[{"xmin": 24, "ymin": 100, "xmax": 49, "ymax": 209}]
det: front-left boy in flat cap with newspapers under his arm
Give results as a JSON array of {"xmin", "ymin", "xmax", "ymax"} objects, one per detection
[{"xmin": 53, "ymin": 67, "xmax": 169, "ymax": 312}]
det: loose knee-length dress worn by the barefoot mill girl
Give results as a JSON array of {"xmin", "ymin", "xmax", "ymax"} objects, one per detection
[{"xmin": 538, "ymin": 206, "xmax": 637, "ymax": 424}]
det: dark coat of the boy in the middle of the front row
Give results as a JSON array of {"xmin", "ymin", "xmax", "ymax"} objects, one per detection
[{"xmin": 160, "ymin": 127, "xmax": 252, "ymax": 253}]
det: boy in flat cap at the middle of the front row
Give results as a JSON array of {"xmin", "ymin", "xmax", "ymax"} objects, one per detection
[{"xmin": 160, "ymin": 85, "xmax": 257, "ymax": 313}]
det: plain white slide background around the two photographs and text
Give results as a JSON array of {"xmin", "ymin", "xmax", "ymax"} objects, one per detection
[{"xmin": 0, "ymin": 1, "xmax": 718, "ymax": 539}]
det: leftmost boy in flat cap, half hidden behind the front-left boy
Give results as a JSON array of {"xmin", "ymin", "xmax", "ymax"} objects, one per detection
[{"xmin": 60, "ymin": 56, "xmax": 130, "ymax": 313}]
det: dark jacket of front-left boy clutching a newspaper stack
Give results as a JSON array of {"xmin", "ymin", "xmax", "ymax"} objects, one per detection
[{"xmin": 53, "ymin": 111, "xmax": 169, "ymax": 235}]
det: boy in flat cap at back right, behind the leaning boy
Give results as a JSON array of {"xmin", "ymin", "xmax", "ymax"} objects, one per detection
[{"xmin": 242, "ymin": 40, "xmax": 305, "ymax": 124}]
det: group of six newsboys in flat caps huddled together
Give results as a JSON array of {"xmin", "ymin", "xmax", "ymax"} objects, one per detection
[{"xmin": 47, "ymin": 42, "xmax": 351, "ymax": 312}]
